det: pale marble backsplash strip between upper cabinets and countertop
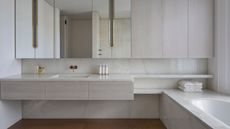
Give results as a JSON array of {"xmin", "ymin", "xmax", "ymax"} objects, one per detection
[{"xmin": 22, "ymin": 59, "xmax": 208, "ymax": 74}]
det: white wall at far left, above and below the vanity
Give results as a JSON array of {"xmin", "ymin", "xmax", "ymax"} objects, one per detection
[{"xmin": 0, "ymin": 0, "xmax": 22, "ymax": 129}]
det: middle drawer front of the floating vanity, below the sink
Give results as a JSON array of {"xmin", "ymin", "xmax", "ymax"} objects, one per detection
[{"xmin": 46, "ymin": 82, "xmax": 89, "ymax": 100}]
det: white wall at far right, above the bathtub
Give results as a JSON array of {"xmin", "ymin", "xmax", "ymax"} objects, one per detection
[{"xmin": 209, "ymin": 0, "xmax": 230, "ymax": 94}]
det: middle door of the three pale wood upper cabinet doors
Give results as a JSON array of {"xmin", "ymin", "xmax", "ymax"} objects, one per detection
[{"xmin": 163, "ymin": 0, "xmax": 189, "ymax": 58}]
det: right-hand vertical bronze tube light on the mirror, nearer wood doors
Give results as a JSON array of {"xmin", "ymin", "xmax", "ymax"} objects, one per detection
[{"xmin": 109, "ymin": 0, "xmax": 115, "ymax": 47}]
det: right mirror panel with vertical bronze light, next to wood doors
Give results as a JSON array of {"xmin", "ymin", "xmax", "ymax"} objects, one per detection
[{"xmin": 93, "ymin": 0, "xmax": 131, "ymax": 58}]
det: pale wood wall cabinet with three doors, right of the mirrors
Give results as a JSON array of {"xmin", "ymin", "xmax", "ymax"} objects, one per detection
[{"xmin": 132, "ymin": 0, "xmax": 214, "ymax": 58}]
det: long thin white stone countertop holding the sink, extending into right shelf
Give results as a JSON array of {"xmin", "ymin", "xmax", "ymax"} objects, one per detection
[{"xmin": 0, "ymin": 74, "xmax": 213, "ymax": 81}]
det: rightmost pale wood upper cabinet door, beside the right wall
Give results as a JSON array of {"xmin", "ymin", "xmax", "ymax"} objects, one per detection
[{"xmin": 189, "ymin": 0, "xmax": 214, "ymax": 58}]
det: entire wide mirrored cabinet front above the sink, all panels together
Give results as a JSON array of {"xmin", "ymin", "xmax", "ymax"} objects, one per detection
[{"xmin": 15, "ymin": 0, "xmax": 131, "ymax": 59}]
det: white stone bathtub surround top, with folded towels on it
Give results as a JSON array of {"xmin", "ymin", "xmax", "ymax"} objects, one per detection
[{"xmin": 163, "ymin": 89, "xmax": 230, "ymax": 129}]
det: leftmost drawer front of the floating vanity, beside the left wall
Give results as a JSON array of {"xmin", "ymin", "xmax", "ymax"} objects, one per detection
[{"xmin": 1, "ymin": 82, "xmax": 45, "ymax": 100}]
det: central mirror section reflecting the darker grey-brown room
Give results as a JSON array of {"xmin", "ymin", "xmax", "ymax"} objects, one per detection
[{"xmin": 55, "ymin": 0, "xmax": 92, "ymax": 58}]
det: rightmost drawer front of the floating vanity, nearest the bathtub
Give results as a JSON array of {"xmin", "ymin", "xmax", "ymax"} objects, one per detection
[{"xmin": 89, "ymin": 82, "xmax": 134, "ymax": 100}]
